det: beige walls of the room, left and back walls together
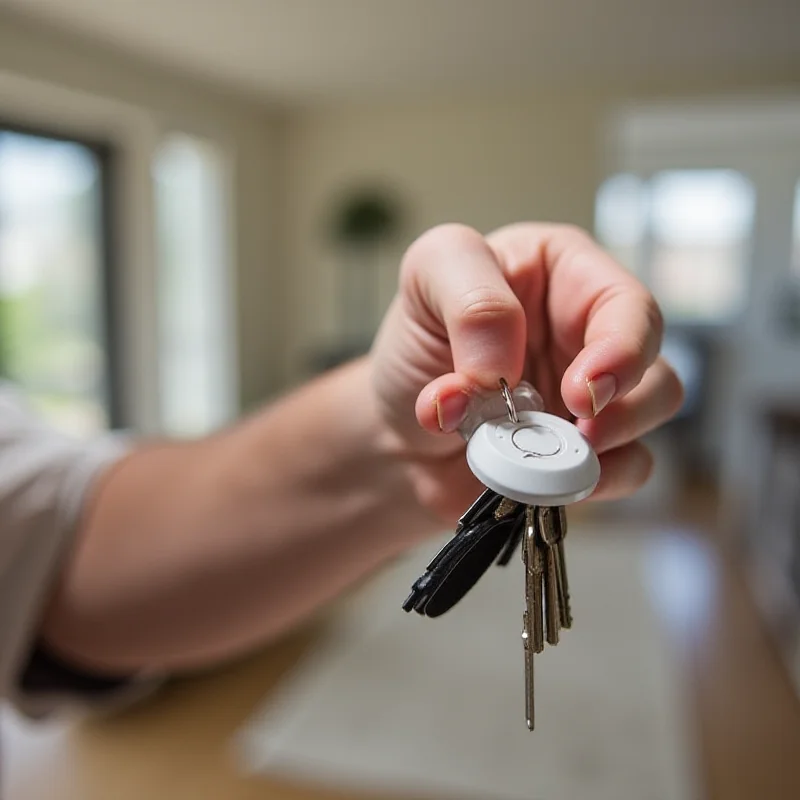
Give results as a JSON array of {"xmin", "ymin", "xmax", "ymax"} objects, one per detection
[{"xmin": 0, "ymin": 12, "xmax": 800, "ymax": 406}]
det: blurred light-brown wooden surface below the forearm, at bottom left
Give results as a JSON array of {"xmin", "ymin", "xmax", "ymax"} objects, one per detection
[{"xmin": 3, "ymin": 629, "xmax": 400, "ymax": 800}]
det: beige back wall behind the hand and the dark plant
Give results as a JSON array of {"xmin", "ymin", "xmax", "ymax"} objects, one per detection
[{"xmin": 284, "ymin": 72, "xmax": 800, "ymax": 380}]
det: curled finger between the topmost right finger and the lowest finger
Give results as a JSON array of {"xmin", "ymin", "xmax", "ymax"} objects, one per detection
[{"xmin": 578, "ymin": 358, "xmax": 683, "ymax": 453}]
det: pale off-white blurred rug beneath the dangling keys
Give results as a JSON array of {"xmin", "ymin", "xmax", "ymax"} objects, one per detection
[{"xmin": 238, "ymin": 531, "xmax": 697, "ymax": 800}]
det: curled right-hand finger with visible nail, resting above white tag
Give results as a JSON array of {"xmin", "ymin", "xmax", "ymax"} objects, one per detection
[{"xmin": 488, "ymin": 224, "xmax": 663, "ymax": 418}]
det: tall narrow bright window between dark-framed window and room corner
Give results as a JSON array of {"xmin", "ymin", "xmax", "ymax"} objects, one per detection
[{"xmin": 153, "ymin": 135, "xmax": 238, "ymax": 437}]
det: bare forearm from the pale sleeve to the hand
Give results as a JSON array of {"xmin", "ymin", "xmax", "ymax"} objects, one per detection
[{"xmin": 44, "ymin": 361, "xmax": 437, "ymax": 670}]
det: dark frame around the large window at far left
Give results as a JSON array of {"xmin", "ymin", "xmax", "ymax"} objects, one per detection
[{"xmin": 0, "ymin": 115, "xmax": 123, "ymax": 428}]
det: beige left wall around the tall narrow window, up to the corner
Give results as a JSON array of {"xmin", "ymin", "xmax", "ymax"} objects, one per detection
[{"xmin": 0, "ymin": 12, "xmax": 284, "ymax": 412}]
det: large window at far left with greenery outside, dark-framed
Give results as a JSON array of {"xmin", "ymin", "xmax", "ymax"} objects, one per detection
[{"xmin": 0, "ymin": 127, "xmax": 116, "ymax": 435}]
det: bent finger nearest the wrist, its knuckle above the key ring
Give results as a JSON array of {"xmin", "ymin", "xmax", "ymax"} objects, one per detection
[{"xmin": 401, "ymin": 225, "xmax": 525, "ymax": 389}]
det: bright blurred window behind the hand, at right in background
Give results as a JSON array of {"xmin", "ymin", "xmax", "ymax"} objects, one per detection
[{"xmin": 596, "ymin": 169, "xmax": 755, "ymax": 324}]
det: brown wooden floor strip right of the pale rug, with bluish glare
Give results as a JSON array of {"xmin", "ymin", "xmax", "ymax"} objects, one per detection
[{"xmin": 648, "ymin": 484, "xmax": 800, "ymax": 800}]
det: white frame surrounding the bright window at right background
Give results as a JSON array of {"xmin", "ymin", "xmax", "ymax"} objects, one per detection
[{"xmin": 597, "ymin": 104, "xmax": 800, "ymax": 340}]
